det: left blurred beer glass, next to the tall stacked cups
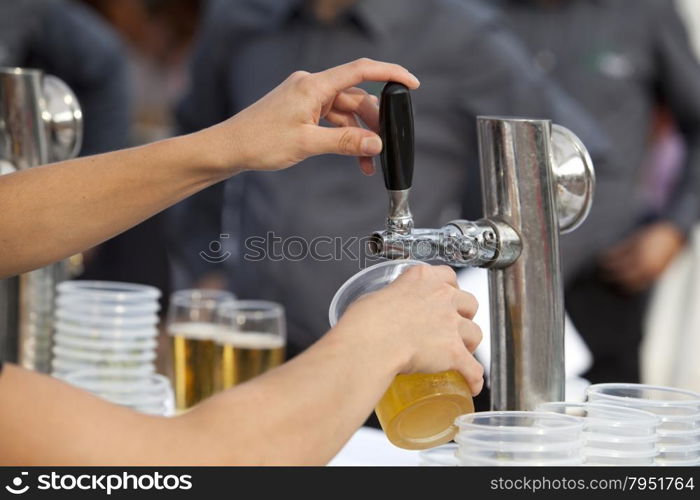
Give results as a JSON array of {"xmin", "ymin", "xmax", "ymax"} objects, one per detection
[{"xmin": 167, "ymin": 290, "xmax": 235, "ymax": 410}]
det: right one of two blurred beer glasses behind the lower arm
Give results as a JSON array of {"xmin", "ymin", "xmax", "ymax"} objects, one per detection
[{"xmin": 216, "ymin": 300, "xmax": 287, "ymax": 389}]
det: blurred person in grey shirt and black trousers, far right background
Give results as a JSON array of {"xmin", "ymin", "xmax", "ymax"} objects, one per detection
[{"xmin": 500, "ymin": 0, "xmax": 700, "ymax": 382}]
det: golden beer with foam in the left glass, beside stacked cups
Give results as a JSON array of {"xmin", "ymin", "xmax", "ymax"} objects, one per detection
[{"xmin": 168, "ymin": 322, "xmax": 220, "ymax": 410}]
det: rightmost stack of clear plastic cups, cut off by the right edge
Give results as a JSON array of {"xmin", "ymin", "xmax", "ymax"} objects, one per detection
[{"xmin": 587, "ymin": 384, "xmax": 700, "ymax": 466}]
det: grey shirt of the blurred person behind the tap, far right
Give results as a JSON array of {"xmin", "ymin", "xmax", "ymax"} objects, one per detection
[{"xmin": 500, "ymin": 0, "xmax": 700, "ymax": 259}]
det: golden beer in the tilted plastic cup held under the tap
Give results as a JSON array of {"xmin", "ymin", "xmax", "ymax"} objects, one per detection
[{"xmin": 375, "ymin": 370, "xmax": 474, "ymax": 450}]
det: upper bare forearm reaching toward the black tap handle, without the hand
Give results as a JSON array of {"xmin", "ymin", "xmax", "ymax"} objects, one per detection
[{"xmin": 0, "ymin": 131, "xmax": 231, "ymax": 276}]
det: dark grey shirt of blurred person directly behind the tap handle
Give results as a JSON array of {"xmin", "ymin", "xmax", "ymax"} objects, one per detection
[{"xmin": 173, "ymin": 0, "xmax": 605, "ymax": 352}]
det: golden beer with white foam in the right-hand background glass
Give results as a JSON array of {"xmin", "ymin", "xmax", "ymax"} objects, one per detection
[{"xmin": 216, "ymin": 331, "xmax": 285, "ymax": 390}]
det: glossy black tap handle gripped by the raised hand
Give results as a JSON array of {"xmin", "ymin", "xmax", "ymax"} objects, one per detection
[{"xmin": 379, "ymin": 82, "xmax": 413, "ymax": 191}]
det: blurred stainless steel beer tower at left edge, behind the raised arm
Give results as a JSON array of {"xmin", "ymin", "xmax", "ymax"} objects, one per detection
[{"xmin": 0, "ymin": 68, "xmax": 82, "ymax": 372}]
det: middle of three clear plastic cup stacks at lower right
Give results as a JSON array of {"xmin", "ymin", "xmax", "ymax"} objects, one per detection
[{"xmin": 537, "ymin": 402, "xmax": 661, "ymax": 466}]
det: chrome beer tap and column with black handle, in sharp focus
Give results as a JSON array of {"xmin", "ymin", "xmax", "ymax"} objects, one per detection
[{"xmin": 369, "ymin": 82, "xmax": 595, "ymax": 410}]
